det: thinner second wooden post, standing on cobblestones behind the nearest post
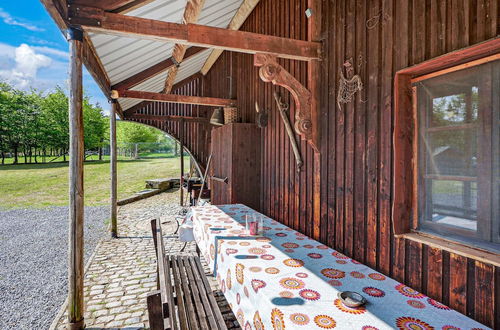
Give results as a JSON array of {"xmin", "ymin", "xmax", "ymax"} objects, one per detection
[{"xmin": 109, "ymin": 100, "xmax": 118, "ymax": 238}]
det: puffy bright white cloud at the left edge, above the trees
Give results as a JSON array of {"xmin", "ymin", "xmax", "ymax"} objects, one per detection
[{"xmin": 0, "ymin": 44, "xmax": 53, "ymax": 89}]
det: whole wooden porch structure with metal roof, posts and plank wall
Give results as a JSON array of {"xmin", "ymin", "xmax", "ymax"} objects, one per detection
[{"xmin": 41, "ymin": 0, "xmax": 500, "ymax": 329}]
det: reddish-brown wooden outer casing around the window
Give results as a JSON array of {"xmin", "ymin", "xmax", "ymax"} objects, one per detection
[{"xmin": 392, "ymin": 38, "xmax": 500, "ymax": 255}]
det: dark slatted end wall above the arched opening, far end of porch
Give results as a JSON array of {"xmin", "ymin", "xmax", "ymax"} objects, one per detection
[{"xmin": 127, "ymin": 78, "xmax": 211, "ymax": 166}]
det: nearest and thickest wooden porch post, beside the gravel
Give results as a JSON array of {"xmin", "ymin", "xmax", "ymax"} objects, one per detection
[{"xmin": 67, "ymin": 27, "xmax": 85, "ymax": 329}]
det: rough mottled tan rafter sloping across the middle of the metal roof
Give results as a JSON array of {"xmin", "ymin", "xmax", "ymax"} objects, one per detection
[{"xmin": 163, "ymin": 0, "xmax": 205, "ymax": 94}]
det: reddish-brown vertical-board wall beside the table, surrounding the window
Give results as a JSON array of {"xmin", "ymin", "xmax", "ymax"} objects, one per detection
[{"xmin": 203, "ymin": 0, "xmax": 500, "ymax": 328}]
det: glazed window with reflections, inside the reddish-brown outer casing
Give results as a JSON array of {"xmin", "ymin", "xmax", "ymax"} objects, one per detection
[{"xmin": 411, "ymin": 56, "xmax": 500, "ymax": 252}]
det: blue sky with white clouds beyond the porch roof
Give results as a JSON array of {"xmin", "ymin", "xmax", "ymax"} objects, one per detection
[{"xmin": 0, "ymin": 0, "xmax": 109, "ymax": 113}]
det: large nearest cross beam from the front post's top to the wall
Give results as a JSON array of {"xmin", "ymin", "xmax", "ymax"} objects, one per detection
[{"xmin": 68, "ymin": 5, "xmax": 321, "ymax": 61}]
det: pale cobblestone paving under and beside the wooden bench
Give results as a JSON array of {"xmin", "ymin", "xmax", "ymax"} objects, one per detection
[{"xmin": 56, "ymin": 191, "xmax": 239, "ymax": 329}]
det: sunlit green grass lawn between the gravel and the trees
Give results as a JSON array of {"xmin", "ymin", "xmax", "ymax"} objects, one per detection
[{"xmin": 0, "ymin": 157, "xmax": 189, "ymax": 208}]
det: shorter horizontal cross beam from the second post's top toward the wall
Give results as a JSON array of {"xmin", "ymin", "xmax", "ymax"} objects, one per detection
[{"xmin": 116, "ymin": 90, "xmax": 236, "ymax": 107}]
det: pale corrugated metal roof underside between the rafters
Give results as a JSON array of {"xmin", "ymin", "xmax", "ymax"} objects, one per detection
[{"xmin": 90, "ymin": 0, "xmax": 243, "ymax": 110}]
